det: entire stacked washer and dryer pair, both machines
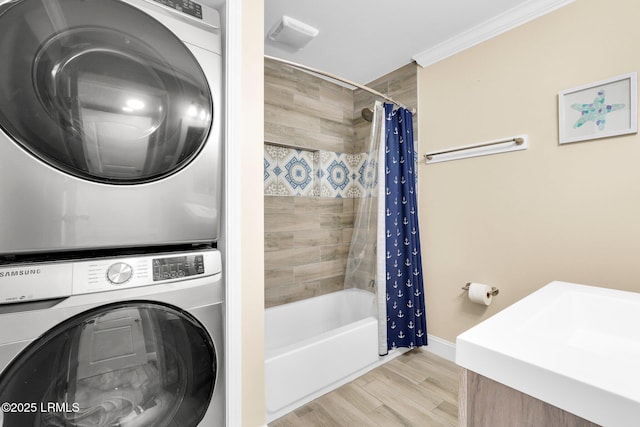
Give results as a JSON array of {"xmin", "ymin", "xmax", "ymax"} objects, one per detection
[{"xmin": 0, "ymin": 0, "xmax": 225, "ymax": 427}]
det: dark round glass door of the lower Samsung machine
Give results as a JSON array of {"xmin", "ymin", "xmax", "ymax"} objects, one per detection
[{"xmin": 0, "ymin": 302, "xmax": 217, "ymax": 427}]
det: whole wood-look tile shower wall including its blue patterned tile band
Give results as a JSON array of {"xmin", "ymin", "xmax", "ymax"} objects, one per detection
[{"xmin": 264, "ymin": 60, "xmax": 417, "ymax": 307}]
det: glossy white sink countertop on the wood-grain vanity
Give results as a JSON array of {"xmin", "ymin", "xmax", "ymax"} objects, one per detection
[{"xmin": 456, "ymin": 282, "xmax": 640, "ymax": 427}]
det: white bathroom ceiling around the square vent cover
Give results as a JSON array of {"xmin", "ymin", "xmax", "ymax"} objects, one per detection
[{"xmin": 264, "ymin": 0, "xmax": 573, "ymax": 84}]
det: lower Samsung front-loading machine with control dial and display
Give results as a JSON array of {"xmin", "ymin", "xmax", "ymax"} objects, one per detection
[{"xmin": 0, "ymin": 249, "xmax": 225, "ymax": 427}]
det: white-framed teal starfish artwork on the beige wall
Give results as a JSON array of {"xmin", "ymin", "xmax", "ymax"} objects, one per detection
[{"xmin": 558, "ymin": 72, "xmax": 638, "ymax": 144}]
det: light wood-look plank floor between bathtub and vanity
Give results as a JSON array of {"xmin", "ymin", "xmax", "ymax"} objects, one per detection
[{"xmin": 269, "ymin": 349, "xmax": 461, "ymax": 427}]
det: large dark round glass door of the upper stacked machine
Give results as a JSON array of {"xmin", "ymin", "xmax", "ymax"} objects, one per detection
[{"xmin": 0, "ymin": 0, "xmax": 214, "ymax": 184}]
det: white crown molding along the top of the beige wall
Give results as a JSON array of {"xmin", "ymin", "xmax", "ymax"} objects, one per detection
[{"xmin": 412, "ymin": 0, "xmax": 575, "ymax": 68}]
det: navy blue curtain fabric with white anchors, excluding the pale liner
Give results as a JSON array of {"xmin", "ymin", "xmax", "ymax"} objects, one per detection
[{"xmin": 384, "ymin": 104, "xmax": 427, "ymax": 349}]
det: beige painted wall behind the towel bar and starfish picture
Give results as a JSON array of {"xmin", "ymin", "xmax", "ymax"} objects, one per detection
[{"xmin": 418, "ymin": 0, "xmax": 640, "ymax": 341}]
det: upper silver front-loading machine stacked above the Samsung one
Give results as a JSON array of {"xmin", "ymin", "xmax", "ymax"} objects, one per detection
[{"xmin": 0, "ymin": 0, "xmax": 222, "ymax": 255}]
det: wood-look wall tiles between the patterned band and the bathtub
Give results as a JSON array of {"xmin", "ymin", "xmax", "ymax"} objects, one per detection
[{"xmin": 265, "ymin": 196, "xmax": 355, "ymax": 307}]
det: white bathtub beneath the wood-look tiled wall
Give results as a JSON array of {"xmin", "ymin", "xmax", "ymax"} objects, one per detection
[{"xmin": 265, "ymin": 289, "xmax": 406, "ymax": 422}]
